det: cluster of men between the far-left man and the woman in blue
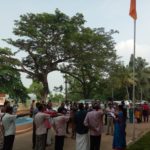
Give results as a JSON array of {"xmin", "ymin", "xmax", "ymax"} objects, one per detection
[{"xmin": 29, "ymin": 102, "xmax": 103, "ymax": 150}]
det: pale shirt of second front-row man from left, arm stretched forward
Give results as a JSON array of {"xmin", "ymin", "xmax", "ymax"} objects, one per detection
[{"xmin": 34, "ymin": 112, "xmax": 50, "ymax": 135}]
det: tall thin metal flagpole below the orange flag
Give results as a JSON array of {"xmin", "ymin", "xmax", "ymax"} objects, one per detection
[{"xmin": 132, "ymin": 20, "xmax": 136, "ymax": 141}]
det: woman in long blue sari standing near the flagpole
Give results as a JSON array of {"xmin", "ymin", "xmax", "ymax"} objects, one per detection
[{"xmin": 113, "ymin": 105, "xmax": 126, "ymax": 150}]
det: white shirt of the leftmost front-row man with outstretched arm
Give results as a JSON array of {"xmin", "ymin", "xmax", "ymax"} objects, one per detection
[{"xmin": 2, "ymin": 113, "xmax": 17, "ymax": 136}]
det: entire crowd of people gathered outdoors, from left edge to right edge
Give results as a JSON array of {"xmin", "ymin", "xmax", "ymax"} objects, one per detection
[{"xmin": 0, "ymin": 100, "xmax": 149, "ymax": 150}]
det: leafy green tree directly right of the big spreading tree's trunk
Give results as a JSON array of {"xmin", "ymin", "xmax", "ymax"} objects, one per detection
[{"xmin": 62, "ymin": 28, "xmax": 117, "ymax": 99}]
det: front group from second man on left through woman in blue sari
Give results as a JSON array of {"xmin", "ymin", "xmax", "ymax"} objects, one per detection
[{"xmin": 30, "ymin": 101, "xmax": 126, "ymax": 150}]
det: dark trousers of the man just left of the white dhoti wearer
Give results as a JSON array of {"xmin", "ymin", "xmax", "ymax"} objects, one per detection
[{"xmin": 55, "ymin": 135, "xmax": 65, "ymax": 150}]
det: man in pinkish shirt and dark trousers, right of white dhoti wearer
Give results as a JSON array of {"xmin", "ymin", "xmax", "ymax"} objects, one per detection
[{"xmin": 84, "ymin": 103, "xmax": 103, "ymax": 150}]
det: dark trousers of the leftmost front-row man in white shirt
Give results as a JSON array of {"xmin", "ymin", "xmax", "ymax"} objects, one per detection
[{"xmin": 3, "ymin": 135, "xmax": 15, "ymax": 150}]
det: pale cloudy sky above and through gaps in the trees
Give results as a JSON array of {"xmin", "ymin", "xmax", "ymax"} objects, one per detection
[{"xmin": 0, "ymin": 0, "xmax": 150, "ymax": 90}]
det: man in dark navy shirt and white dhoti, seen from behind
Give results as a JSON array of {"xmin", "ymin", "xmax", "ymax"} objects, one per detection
[{"xmin": 74, "ymin": 103, "xmax": 89, "ymax": 150}]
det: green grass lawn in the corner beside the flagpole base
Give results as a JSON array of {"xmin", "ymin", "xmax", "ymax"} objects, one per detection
[{"xmin": 127, "ymin": 132, "xmax": 150, "ymax": 150}]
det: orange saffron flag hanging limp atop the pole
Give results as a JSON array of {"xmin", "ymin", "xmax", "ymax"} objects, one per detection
[{"xmin": 129, "ymin": 0, "xmax": 137, "ymax": 20}]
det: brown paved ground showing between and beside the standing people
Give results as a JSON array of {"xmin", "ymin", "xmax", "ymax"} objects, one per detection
[{"xmin": 13, "ymin": 123, "xmax": 150, "ymax": 150}]
